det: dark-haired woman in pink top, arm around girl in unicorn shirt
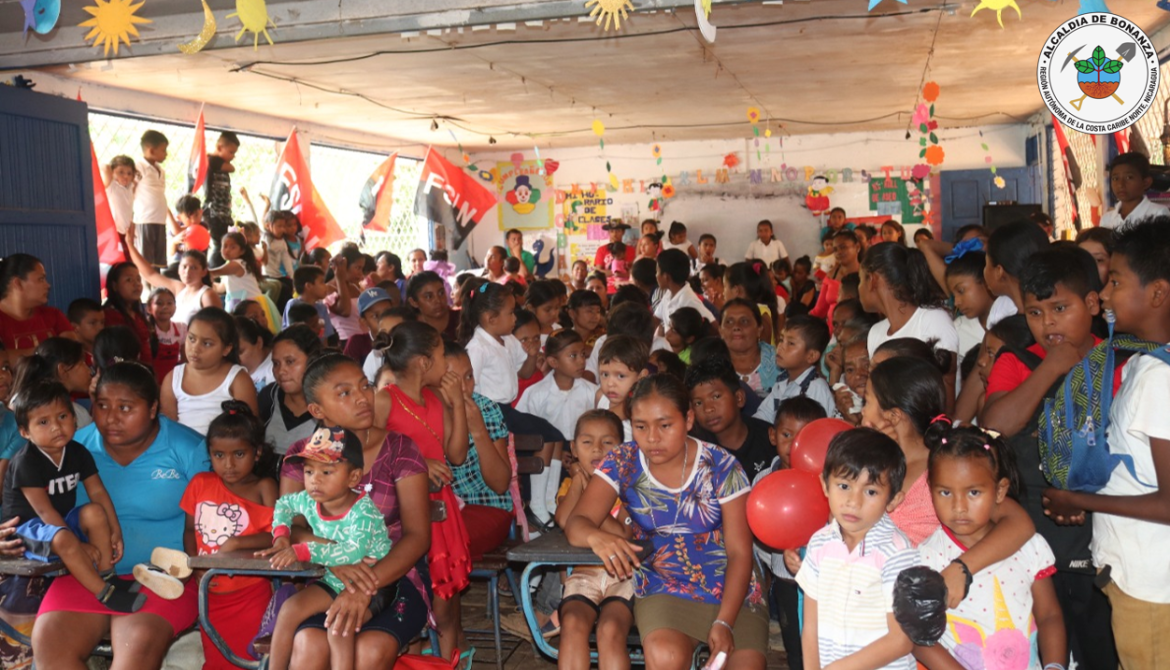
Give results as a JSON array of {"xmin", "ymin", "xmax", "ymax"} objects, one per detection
[{"xmin": 861, "ymin": 351, "xmax": 1035, "ymax": 607}]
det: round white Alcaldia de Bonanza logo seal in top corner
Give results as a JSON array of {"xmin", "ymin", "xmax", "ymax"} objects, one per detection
[{"xmin": 1035, "ymin": 12, "xmax": 1158, "ymax": 134}]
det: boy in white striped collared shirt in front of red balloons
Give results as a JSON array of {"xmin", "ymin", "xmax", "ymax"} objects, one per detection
[{"xmin": 797, "ymin": 428, "xmax": 918, "ymax": 670}]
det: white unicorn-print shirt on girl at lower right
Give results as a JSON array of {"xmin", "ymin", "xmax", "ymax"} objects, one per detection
[{"xmin": 918, "ymin": 526, "xmax": 1057, "ymax": 670}]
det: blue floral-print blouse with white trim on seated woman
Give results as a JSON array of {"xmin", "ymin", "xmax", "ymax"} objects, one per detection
[{"xmin": 596, "ymin": 441, "xmax": 763, "ymax": 605}]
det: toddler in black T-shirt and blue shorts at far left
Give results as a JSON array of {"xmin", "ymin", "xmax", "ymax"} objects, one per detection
[{"xmin": 0, "ymin": 382, "xmax": 146, "ymax": 614}]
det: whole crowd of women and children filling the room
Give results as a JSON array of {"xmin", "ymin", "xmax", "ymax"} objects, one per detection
[{"xmin": 0, "ymin": 140, "xmax": 1170, "ymax": 670}]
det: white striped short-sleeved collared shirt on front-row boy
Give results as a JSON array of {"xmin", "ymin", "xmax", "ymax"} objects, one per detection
[{"xmin": 797, "ymin": 514, "xmax": 918, "ymax": 670}]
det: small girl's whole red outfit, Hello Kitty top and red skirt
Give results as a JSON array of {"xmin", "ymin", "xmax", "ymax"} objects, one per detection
[{"xmin": 179, "ymin": 472, "xmax": 273, "ymax": 670}]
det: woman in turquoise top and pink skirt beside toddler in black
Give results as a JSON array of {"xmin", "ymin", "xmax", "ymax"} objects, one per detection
[{"xmin": 33, "ymin": 361, "xmax": 211, "ymax": 668}]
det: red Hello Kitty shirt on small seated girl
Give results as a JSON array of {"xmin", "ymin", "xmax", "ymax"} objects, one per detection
[{"xmin": 179, "ymin": 472, "xmax": 273, "ymax": 593}]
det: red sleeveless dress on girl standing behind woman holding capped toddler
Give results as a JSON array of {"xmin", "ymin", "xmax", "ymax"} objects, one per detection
[{"xmin": 386, "ymin": 386, "xmax": 472, "ymax": 600}]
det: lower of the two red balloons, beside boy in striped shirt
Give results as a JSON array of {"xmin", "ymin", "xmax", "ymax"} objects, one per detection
[{"xmin": 748, "ymin": 470, "xmax": 828, "ymax": 550}]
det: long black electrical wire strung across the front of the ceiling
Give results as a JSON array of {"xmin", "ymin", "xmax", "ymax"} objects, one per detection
[{"xmin": 230, "ymin": 4, "xmax": 945, "ymax": 72}]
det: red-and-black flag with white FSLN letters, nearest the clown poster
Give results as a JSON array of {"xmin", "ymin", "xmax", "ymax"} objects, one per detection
[{"xmin": 414, "ymin": 147, "xmax": 496, "ymax": 251}]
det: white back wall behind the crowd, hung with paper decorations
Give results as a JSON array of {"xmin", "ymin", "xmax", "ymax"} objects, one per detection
[{"xmin": 460, "ymin": 123, "xmax": 1027, "ymax": 272}]
